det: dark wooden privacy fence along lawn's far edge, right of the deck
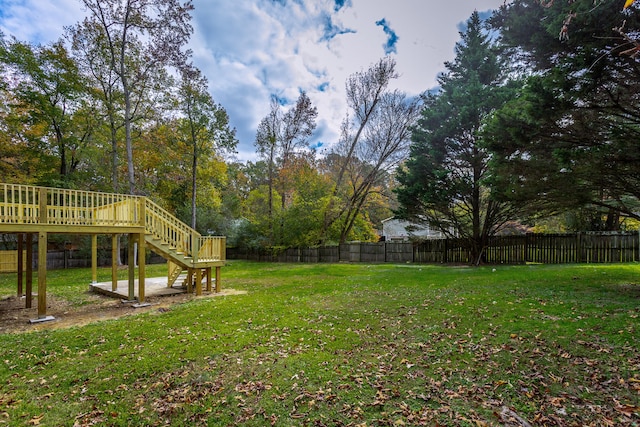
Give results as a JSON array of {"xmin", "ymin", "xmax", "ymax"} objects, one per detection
[{"xmin": 227, "ymin": 232, "xmax": 640, "ymax": 264}]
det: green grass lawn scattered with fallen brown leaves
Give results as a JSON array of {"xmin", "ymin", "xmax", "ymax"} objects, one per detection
[{"xmin": 0, "ymin": 261, "xmax": 640, "ymax": 426}]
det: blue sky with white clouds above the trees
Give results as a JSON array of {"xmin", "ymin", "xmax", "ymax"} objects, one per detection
[{"xmin": 0, "ymin": 0, "xmax": 504, "ymax": 160}]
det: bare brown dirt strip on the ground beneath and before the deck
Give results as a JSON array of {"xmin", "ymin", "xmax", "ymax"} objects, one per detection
[{"xmin": 0, "ymin": 289, "xmax": 244, "ymax": 334}]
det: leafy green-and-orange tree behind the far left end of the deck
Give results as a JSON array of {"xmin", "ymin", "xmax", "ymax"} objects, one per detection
[{"xmin": 0, "ymin": 39, "xmax": 95, "ymax": 186}]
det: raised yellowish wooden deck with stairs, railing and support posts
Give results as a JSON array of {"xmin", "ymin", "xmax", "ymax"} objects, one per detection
[{"xmin": 0, "ymin": 183, "xmax": 226, "ymax": 319}]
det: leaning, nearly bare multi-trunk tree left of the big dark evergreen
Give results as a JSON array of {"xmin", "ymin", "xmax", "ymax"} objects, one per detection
[{"xmin": 320, "ymin": 56, "xmax": 419, "ymax": 242}]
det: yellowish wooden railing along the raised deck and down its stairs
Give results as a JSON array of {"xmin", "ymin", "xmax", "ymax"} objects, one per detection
[{"xmin": 0, "ymin": 183, "xmax": 226, "ymax": 262}]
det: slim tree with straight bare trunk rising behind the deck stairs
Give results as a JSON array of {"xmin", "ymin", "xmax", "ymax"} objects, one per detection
[{"xmin": 178, "ymin": 66, "xmax": 238, "ymax": 229}]
